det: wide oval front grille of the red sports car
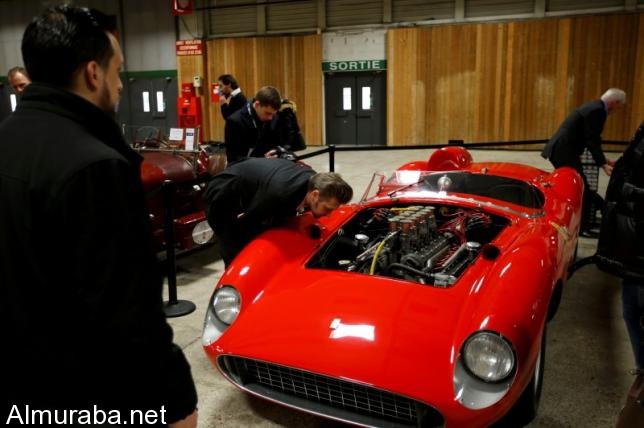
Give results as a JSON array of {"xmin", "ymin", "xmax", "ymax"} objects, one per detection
[{"xmin": 217, "ymin": 356, "xmax": 443, "ymax": 427}]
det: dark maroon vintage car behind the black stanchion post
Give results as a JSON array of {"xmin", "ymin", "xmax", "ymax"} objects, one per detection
[{"xmin": 138, "ymin": 146, "xmax": 225, "ymax": 251}]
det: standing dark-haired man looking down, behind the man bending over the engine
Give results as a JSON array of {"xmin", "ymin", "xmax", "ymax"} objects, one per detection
[{"xmin": 225, "ymin": 86, "xmax": 282, "ymax": 163}]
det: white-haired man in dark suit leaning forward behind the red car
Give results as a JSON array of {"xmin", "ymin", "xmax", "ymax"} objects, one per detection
[{"xmin": 541, "ymin": 88, "xmax": 626, "ymax": 237}]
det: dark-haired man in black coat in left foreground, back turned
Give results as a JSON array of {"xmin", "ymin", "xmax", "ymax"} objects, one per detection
[{"xmin": 0, "ymin": 5, "xmax": 197, "ymax": 427}]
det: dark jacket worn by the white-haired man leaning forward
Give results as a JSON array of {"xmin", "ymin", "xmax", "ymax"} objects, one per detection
[{"xmin": 541, "ymin": 100, "xmax": 607, "ymax": 170}]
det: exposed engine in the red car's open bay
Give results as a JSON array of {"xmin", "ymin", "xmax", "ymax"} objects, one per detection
[{"xmin": 308, "ymin": 205, "xmax": 508, "ymax": 287}]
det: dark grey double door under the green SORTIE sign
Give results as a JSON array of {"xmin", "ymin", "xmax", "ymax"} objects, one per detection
[{"xmin": 325, "ymin": 72, "xmax": 386, "ymax": 146}]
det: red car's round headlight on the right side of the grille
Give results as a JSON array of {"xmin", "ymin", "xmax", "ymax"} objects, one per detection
[{"xmin": 463, "ymin": 331, "xmax": 515, "ymax": 382}]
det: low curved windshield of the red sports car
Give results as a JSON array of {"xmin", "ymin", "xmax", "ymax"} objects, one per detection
[{"xmin": 363, "ymin": 170, "xmax": 544, "ymax": 208}]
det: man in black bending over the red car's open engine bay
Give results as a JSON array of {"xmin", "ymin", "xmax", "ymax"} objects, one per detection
[{"xmin": 204, "ymin": 158, "xmax": 353, "ymax": 266}]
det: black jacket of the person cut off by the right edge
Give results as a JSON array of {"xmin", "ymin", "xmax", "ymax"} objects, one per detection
[{"xmin": 595, "ymin": 122, "xmax": 644, "ymax": 281}]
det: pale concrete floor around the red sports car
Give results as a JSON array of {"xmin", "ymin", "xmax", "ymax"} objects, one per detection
[{"xmin": 169, "ymin": 150, "xmax": 634, "ymax": 428}]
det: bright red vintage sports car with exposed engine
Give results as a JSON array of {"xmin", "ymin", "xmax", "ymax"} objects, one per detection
[{"xmin": 203, "ymin": 147, "xmax": 583, "ymax": 427}]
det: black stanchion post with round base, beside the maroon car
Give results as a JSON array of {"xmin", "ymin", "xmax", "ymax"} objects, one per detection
[{"xmin": 161, "ymin": 180, "xmax": 197, "ymax": 318}]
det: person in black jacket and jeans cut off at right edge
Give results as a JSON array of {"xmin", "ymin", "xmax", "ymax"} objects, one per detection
[{"xmin": 595, "ymin": 122, "xmax": 644, "ymax": 374}]
